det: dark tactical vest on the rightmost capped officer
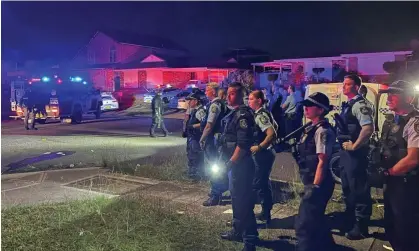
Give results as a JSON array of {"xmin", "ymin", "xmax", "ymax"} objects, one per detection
[{"xmin": 380, "ymin": 111, "xmax": 419, "ymax": 175}]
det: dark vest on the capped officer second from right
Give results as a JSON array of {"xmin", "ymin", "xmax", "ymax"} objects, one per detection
[{"xmin": 297, "ymin": 121, "xmax": 330, "ymax": 185}]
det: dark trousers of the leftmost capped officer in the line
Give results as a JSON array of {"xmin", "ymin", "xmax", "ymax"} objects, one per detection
[{"xmin": 186, "ymin": 136, "xmax": 204, "ymax": 177}]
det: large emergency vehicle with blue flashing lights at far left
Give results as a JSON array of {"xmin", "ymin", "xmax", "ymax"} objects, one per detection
[{"xmin": 10, "ymin": 75, "xmax": 102, "ymax": 124}]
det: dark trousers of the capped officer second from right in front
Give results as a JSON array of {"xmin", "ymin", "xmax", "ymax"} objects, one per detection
[{"xmin": 295, "ymin": 174, "xmax": 335, "ymax": 251}]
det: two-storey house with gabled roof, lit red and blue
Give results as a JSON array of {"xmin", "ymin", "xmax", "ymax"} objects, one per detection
[{"xmin": 71, "ymin": 31, "xmax": 236, "ymax": 91}]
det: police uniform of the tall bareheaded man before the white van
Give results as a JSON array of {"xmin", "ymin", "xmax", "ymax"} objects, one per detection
[{"xmin": 338, "ymin": 95, "xmax": 374, "ymax": 235}]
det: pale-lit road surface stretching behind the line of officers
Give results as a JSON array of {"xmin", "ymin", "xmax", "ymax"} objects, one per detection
[{"xmin": 1, "ymin": 113, "xmax": 298, "ymax": 181}]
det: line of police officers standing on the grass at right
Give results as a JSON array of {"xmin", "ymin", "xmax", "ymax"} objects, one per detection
[{"xmin": 182, "ymin": 75, "xmax": 419, "ymax": 251}]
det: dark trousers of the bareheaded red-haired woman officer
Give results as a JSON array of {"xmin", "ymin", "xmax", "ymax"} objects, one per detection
[{"xmin": 253, "ymin": 150, "xmax": 275, "ymax": 212}]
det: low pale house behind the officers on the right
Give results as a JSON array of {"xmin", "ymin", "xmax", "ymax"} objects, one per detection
[{"xmin": 252, "ymin": 51, "xmax": 412, "ymax": 86}]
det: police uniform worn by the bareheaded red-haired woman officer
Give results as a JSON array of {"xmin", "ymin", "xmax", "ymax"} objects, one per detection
[{"xmin": 253, "ymin": 108, "xmax": 278, "ymax": 221}]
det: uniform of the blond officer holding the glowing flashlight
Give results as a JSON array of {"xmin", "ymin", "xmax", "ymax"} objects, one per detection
[{"xmin": 201, "ymin": 97, "xmax": 228, "ymax": 206}]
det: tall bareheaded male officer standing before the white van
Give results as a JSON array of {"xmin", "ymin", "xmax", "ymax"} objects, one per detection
[{"xmin": 338, "ymin": 75, "xmax": 374, "ymax": 240}]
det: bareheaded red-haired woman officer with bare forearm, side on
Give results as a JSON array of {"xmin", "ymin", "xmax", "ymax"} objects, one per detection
[{"xmin": 249, "ymin": 90, "xmax": 278, "ymax": 223}]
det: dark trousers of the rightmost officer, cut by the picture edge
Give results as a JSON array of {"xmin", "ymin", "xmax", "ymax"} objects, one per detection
[{"xmin": 384, "ymin": 175, "xmax": 419, "ymax": 251}]
